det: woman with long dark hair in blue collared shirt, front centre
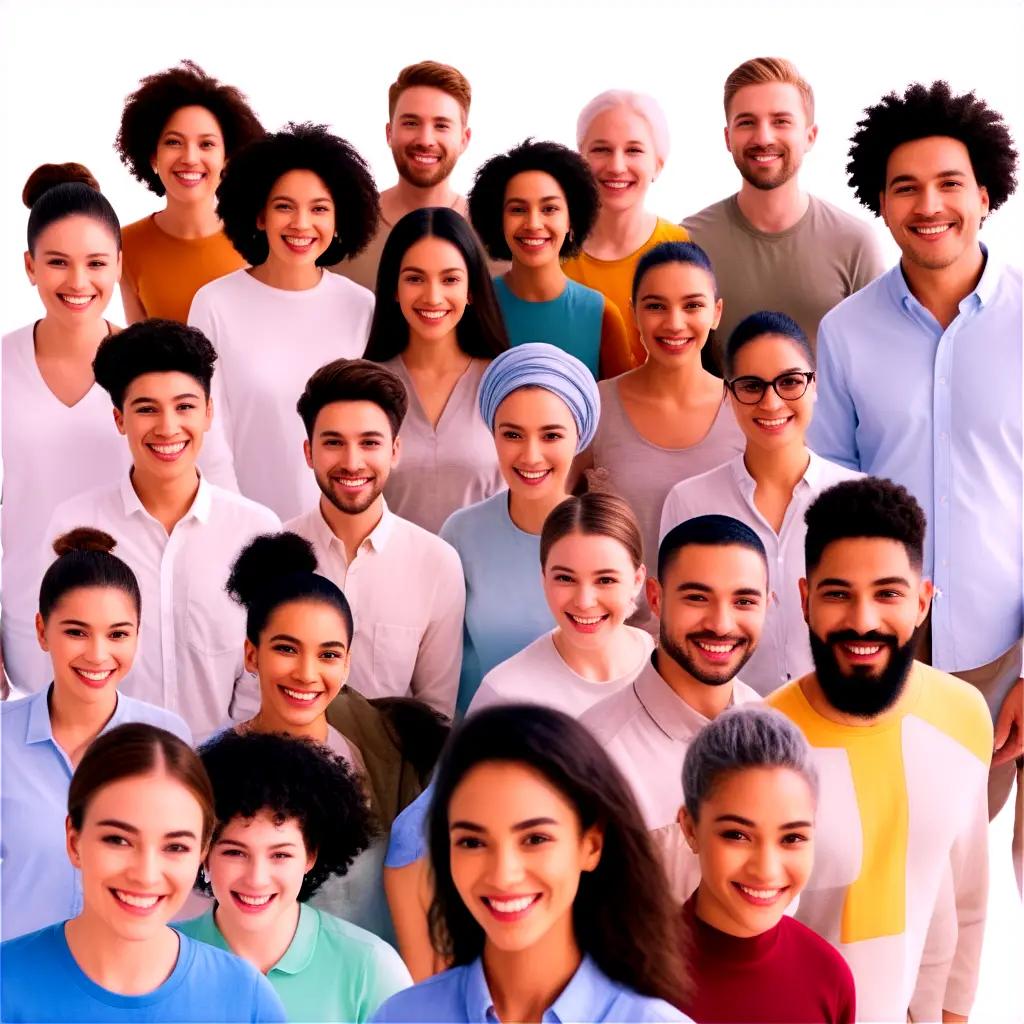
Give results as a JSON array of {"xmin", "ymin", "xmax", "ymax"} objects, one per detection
[{"xmin": 375, "ymin": 705, "xmax": 688, "ymax": 1022}]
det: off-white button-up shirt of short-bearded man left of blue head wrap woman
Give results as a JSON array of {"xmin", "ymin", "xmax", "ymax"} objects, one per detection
[{"xmin": 285, "ymin": 502, "xmax": 466, "ymax": 718}]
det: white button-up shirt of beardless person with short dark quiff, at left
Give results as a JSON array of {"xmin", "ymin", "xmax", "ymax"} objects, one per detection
[{"xmin": 40, "ymin": 474, "xmax": 281, "ymax": 741}]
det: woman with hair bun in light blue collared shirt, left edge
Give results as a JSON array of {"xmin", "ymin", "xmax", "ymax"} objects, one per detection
[{"xmin": 0, "ymin": 527, "xmax": 191, "ymax": 937}]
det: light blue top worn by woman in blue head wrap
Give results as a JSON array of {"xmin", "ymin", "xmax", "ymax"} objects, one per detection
[{"xmin": 440, "ymin": 488, "xmax": 555, "ymax": 715}]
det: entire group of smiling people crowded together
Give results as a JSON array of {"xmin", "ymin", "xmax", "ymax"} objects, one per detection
[{"xmin": 0, "ymin": 44, "xmax": 1024, "ymax": 1022}]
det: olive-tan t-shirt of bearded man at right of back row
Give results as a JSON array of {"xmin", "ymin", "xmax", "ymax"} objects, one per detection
[{"xmin": 683, "ymin": 196, "xmax": 885, "ymax": 366}]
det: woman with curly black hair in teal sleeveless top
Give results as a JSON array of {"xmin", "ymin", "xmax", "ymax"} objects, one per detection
[{"xmin": 469, "ymin": 139, "xmax": 635, "ymax": 378}]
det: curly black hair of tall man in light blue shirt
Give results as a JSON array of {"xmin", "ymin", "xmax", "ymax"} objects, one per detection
[{"xmin": 846, "ymin": 81, "xmax": 1017, "ymax": 216}]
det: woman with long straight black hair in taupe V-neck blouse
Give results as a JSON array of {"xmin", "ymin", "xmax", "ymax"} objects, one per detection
[{"xmin": 366, "ymin": 207, "xmax": 509, "ymax": 534}]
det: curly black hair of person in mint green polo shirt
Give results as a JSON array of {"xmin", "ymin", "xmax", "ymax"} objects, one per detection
[{"xmin": 196, "ymin": 729, "xmax": 377, "ymax": 903}]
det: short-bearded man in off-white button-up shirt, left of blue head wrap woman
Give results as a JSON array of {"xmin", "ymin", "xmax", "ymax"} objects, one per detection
[{"xmin": 285, "ymin": 359, "xmax": 466, "ymax": 718}]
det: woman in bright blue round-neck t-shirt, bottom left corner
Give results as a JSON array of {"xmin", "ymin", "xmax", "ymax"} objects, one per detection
[{"xmin": 0, "ymin": 723, "xmax": 285, "ymax": 1022}]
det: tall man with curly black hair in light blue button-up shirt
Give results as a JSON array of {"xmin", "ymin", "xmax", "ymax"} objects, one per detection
[{"xmin": 808, "ymin": 82, "xmax": 1024, "ymax": 884}]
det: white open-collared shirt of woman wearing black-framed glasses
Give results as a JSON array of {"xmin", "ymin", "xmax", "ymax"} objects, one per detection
[{"xmin": 659, "ymin": 452, "xmax": 863, "ymax": 695}]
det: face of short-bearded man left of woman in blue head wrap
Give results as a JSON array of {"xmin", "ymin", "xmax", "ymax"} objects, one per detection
[{"xmin": 303, "ymin": 401, "xmax": 399, "ymax": 515}]
